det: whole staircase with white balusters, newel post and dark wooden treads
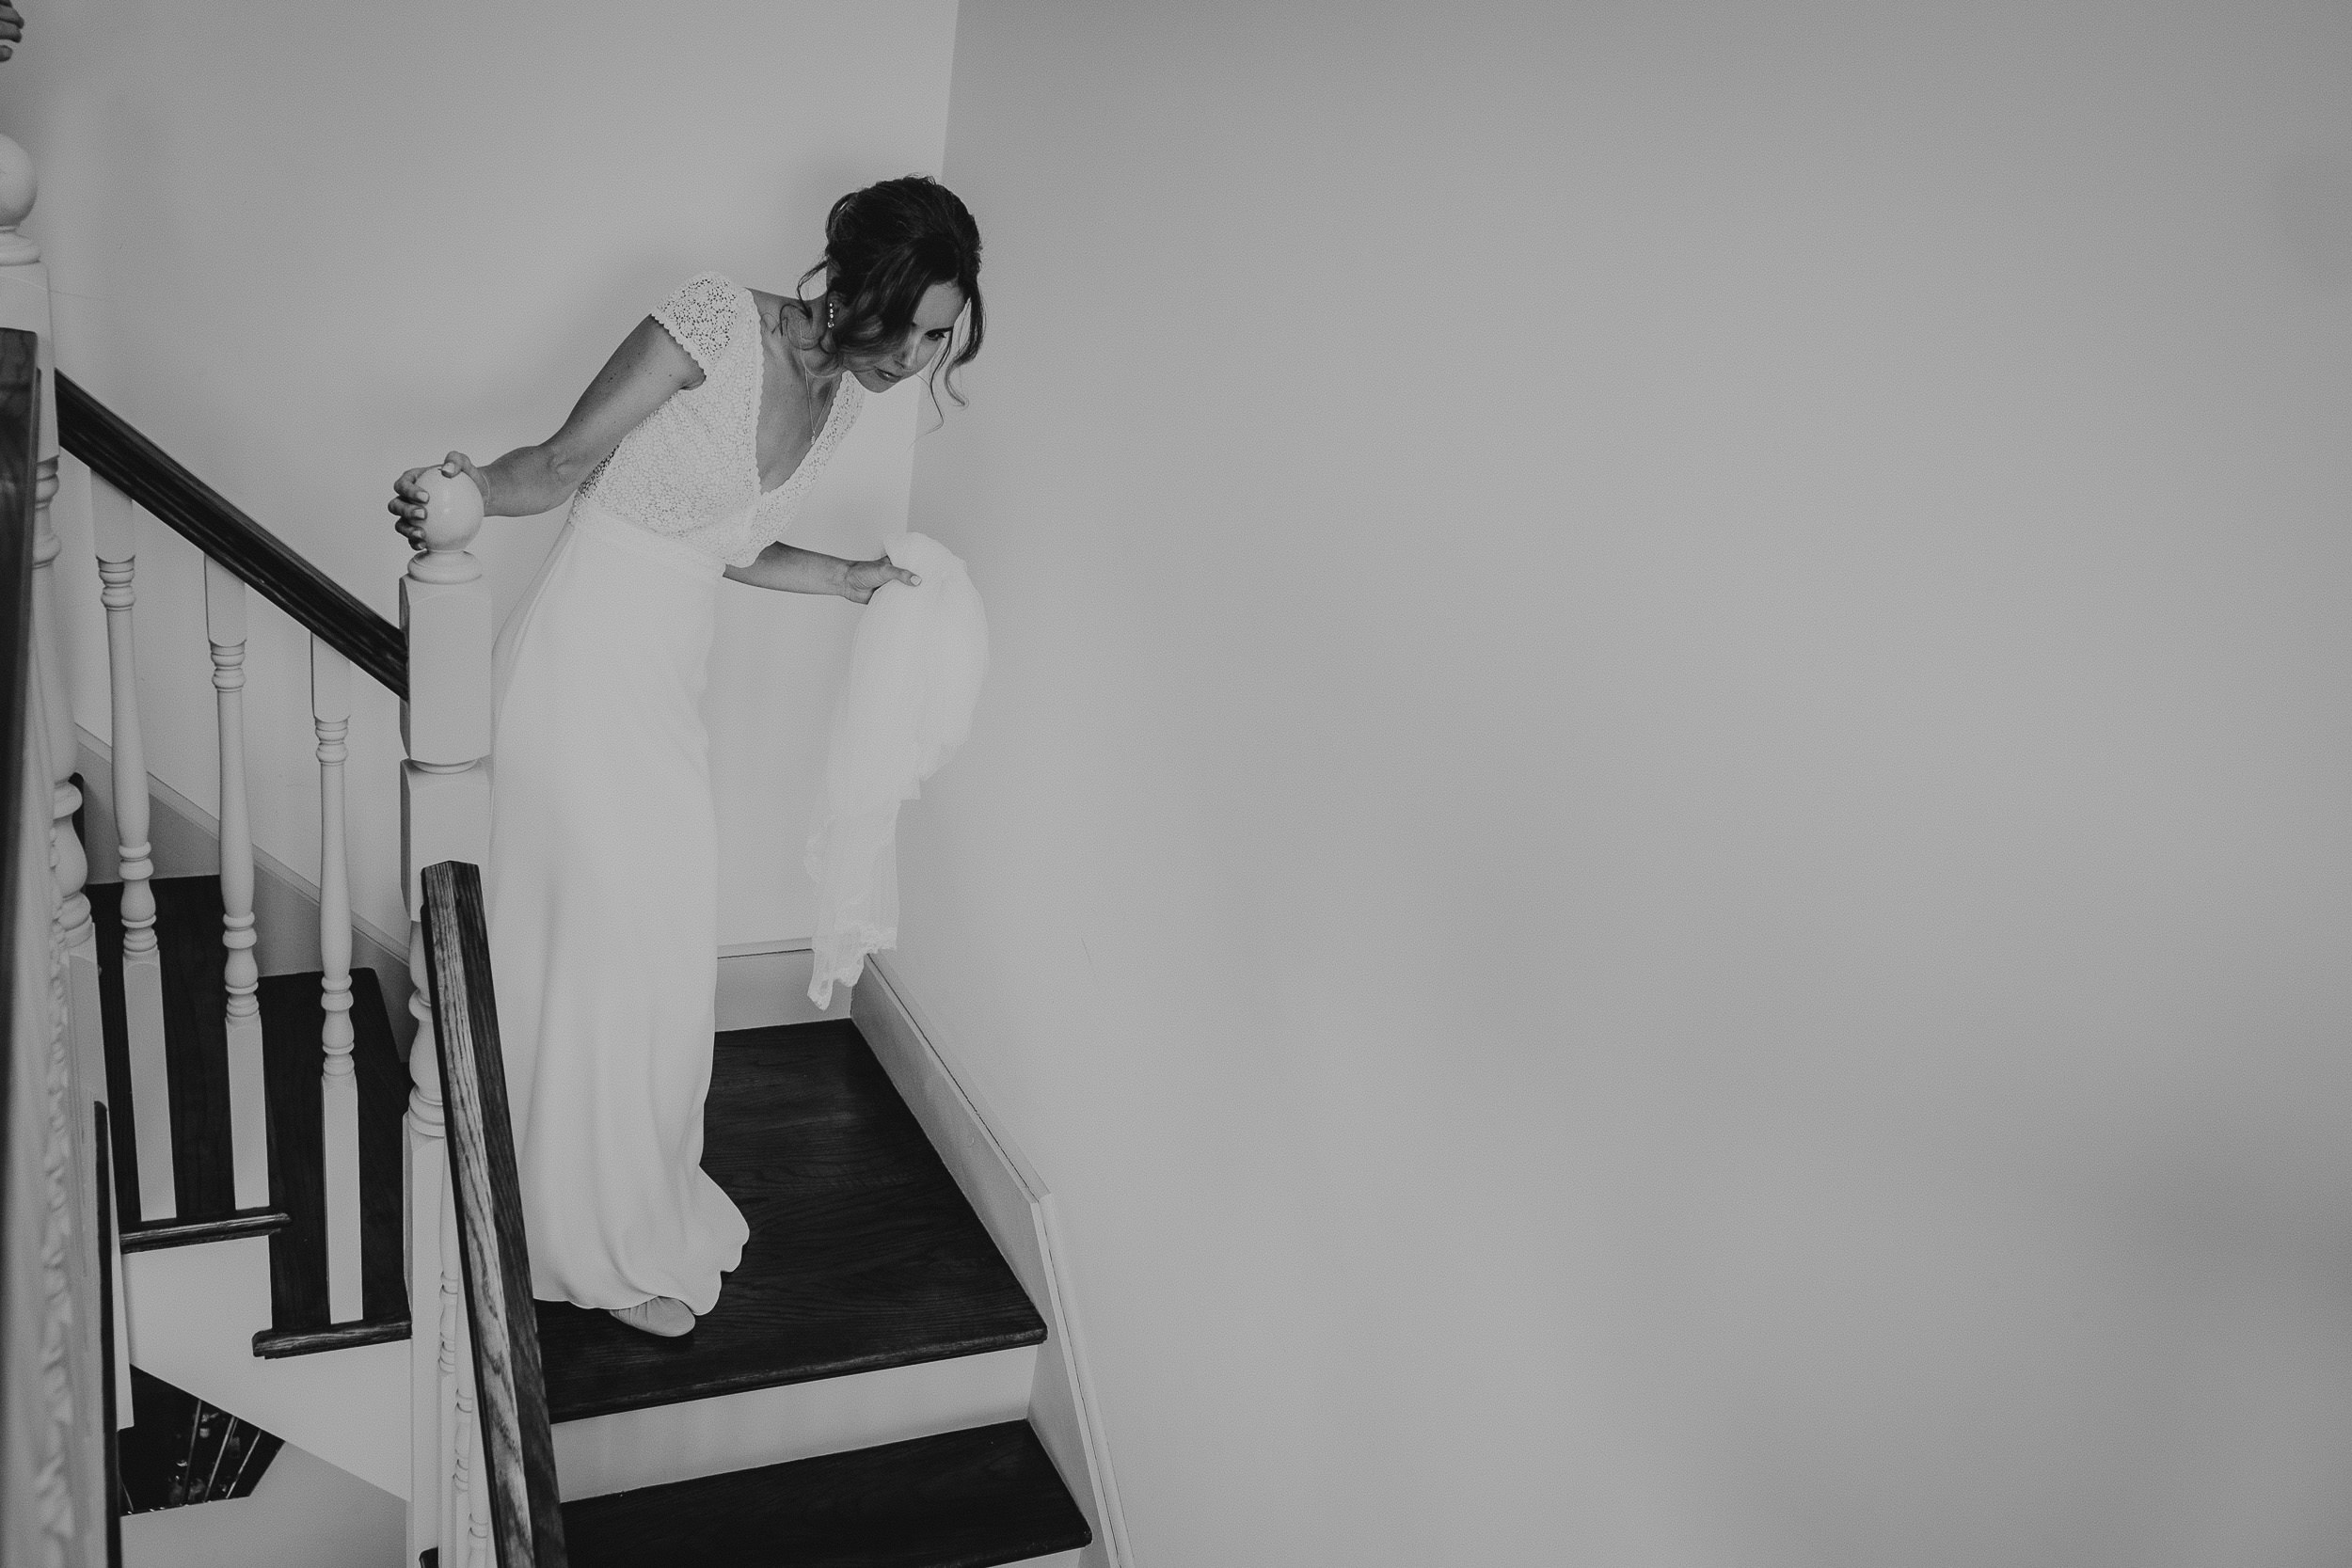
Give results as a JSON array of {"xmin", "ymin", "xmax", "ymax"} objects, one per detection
[{"xmin": 0, "ymin": 150, "xmax": 1127, "ymax": 1568}]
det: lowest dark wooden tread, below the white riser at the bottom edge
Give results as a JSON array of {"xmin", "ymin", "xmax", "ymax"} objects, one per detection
[{"xmin": 564, "ymin": 1420, "xmax": 1094, "ymax": 1568}]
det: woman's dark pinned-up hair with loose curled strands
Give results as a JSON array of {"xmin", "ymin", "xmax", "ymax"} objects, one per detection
[{"xmin": 800, "ymin": 174, "xmax": 988, "ymax": 404}]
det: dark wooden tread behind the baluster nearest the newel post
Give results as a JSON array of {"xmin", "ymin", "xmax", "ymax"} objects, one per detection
[{"xmin": 254, "ymin": 969, "xmax": 409, "ymax": 1356}]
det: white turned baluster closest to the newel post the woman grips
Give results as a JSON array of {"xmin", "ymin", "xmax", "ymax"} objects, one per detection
[{"xmin": 310, "ymin": 637, "xmax": 362, "ymax": 1323}]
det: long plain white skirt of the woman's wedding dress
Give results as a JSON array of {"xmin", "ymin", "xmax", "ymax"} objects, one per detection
[{"xmin": 485, "ymin": 500, "xmax": 751, "ymax": 1314}]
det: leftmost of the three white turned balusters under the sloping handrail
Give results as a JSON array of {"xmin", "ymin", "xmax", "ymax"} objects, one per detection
[{"xmin": 89, "ymin": 477, "xmax": 179, "ymax": 1220}]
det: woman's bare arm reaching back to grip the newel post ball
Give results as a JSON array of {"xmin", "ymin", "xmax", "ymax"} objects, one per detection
[{"xmin": 390, "ymin": 317, "xmax": 704, "ymax": 543}]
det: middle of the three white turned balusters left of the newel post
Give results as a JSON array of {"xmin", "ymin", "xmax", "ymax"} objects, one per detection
[{"xmin": 205, "ymin": 560, "xmax": 271, "ymax": 1209}]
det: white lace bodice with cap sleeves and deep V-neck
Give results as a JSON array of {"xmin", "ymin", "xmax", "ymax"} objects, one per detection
[{"xmin": 579, "ymin": 273, "xmax": 866, "ymax": 566}]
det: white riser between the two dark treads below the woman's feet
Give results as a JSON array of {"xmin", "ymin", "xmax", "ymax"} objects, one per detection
[{"xmin": 555, "ymin": 1345, "xmax": 1035, "ymax": 1504}]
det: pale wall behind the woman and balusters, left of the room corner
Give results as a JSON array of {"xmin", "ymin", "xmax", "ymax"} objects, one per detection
[{"xmin": 0, "ymin": 0, "xmax": 955, "ymax": 942}]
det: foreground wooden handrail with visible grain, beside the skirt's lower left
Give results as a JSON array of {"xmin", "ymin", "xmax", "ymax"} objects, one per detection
[{"xmin": 423, "ymin": 861, "xmax": 564, "ymax": 1568}]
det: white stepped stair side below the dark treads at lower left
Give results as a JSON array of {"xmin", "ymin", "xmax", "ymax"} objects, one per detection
[{"xmin": 122, "ymin": 1237, "xmax": 409, "ymax": 1497}]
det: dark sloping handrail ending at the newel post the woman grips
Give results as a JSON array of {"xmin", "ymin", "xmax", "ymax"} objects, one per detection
[{"xmin": 56, "ymin": 372, "xmax": 409, "ymax": 701}]
